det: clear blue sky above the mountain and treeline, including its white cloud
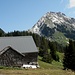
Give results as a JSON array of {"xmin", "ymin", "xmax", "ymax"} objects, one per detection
[{"xmin": 0, "ymin": 0, "xmax": 75, "ymax": 32}]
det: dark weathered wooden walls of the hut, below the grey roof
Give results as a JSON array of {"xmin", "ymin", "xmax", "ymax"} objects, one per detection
[{"xmin": 0, "ymin": 48, "xmax": 38, "ymax": 67}]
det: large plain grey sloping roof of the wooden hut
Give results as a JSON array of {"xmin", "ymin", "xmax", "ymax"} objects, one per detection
[{"xmin": 0, "ymin": 36, "xmax": 38, "ymax": 53}]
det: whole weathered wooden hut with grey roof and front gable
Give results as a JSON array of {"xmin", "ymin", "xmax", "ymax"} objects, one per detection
[{"xmin": 0, "ymin": 36, "xmax": 38, "ymax": 67}]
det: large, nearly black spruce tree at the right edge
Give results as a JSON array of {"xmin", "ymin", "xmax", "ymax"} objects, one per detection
[{"xmin": 63, "ymin": 40, "xmax": 75, "ymax": 70}]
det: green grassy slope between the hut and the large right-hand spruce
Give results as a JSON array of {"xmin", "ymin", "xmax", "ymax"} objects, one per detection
[{"xmin": 38, "ymin": 52, "xmax": 63, "ymax": 69}]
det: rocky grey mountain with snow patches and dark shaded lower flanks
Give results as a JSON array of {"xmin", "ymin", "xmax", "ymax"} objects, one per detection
[{"xmin": 29, "ymin": 12, "xmax": 75, "ymax": 44}]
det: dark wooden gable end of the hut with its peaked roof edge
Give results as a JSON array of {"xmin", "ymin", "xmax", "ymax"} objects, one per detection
[{"xmin": 0, "ymin": 47, "xmax": 24, "ymax": 66}]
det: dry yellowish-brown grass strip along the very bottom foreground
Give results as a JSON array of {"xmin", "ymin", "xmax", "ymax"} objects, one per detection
[{"xmin": 0, "ymin": 69, "xmax": 75, "ymax": 75}]
